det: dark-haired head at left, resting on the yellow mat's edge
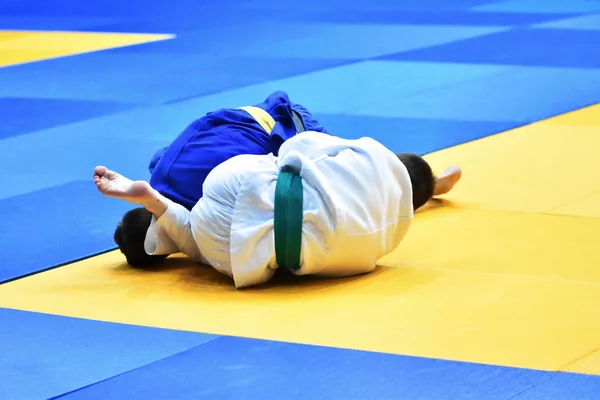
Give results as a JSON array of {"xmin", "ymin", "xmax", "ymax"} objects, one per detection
[{"xmin": 114, "ymin": 207, "xmax": 167, "ymax": 267}]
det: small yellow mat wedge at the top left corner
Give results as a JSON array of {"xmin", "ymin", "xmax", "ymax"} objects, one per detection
[{"xmin": 0, "ymin": 31, "xmax": 173, "ymax": 67}]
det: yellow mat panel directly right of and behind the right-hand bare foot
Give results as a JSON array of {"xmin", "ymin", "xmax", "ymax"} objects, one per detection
[{"xmin": 426, "ymin": 123, "xmax": 600, "ymax": 216}]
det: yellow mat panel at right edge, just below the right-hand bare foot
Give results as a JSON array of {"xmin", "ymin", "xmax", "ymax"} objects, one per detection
[{"xmin": 380, "ymin": 202, "xmax": 600, "ymax": 282}]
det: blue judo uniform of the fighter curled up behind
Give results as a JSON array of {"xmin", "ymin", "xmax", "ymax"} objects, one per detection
[{"xmin": 149, "ymin": 91, "xmax": 328, "ymax": 210}]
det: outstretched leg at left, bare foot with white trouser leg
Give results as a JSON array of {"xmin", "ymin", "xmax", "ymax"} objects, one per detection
[{"xmin": 94, "ymin": 166, "xmax": 205, "ymax": 262}]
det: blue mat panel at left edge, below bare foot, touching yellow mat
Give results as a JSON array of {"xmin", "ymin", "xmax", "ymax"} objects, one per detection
[{"xmin": 0, "ymin": 181, "xmax": 137, "ymax": 282}]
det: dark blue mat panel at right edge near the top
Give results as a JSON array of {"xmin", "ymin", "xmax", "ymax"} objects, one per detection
[{"xmin": 387, "ymin": 29, "xmax": 600, "ymax": 68}]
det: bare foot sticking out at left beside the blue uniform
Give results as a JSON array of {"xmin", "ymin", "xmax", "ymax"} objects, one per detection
[{"xmin": 94, "ymin": 166, "xmax": 155, "ymax": 204}]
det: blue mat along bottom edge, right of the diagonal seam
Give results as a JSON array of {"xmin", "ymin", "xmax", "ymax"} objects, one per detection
[{"xmin": 55, "ymin": 337, "xmax": 600, "ymax": 400}]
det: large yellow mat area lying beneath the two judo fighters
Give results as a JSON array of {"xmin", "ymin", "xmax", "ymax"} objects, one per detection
[{"xmin": 0, "ymin": 103, "xmax": 600, "ymax": 374}]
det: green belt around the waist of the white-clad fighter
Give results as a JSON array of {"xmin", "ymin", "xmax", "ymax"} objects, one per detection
[{"xmin": 273, "ymin": 166, "xmax": 303, "ymax": 271}]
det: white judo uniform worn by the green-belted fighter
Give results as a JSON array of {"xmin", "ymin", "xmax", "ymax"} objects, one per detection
[{"xmin": 145, "ymin": 132, "xmax": 414, "ymax": 288}]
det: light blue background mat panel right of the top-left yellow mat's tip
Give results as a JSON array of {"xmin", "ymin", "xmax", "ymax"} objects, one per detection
[{"xmin": 99, "ymin": 20, "xmax": 510, "ymax": 62}]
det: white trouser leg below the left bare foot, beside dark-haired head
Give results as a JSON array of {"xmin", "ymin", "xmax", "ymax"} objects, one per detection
[{"xmin": 144, "ymin": 200, "xmax": 206, "ymax": 263}]
